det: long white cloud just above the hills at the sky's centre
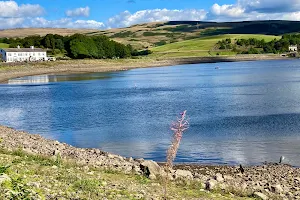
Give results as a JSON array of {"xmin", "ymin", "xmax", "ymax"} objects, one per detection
[{"xmin": 107, "ymin": 9, "xmax": 207, "ymax": 27}]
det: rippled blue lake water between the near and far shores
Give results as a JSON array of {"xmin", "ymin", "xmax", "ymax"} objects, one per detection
[{"xmin": 0, "ymin": 60, "xmax": 300, "ymax": 166}]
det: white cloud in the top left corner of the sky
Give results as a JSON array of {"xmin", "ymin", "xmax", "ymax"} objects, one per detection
[{"xmin": 0, "ymin": 1, "xmax": 44, "ymax": 17}]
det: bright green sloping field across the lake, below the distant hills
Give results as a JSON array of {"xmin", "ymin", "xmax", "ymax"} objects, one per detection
[{"xmin": 151, "ymin": 34, "xmax": 280, "ymax": 58}]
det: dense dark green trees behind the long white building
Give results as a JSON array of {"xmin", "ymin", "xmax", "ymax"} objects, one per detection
[{"xmin": 0, "ymin": 34, "xmax": 151, "ymax": 59}]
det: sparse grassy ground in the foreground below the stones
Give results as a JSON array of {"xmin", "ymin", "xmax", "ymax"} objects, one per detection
[{"xmin": 0, "ymin": 149, "xmax": 253, "ymax": 200}]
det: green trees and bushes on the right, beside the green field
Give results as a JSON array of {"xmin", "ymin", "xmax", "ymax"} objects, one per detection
[{"xmin": 217, "ymin": 34, "xmax": 300, "ymax": 54}]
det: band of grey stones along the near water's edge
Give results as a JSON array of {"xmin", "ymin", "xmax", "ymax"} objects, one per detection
[{"xmin": 0, "ymin": 126, "xmax": 300, "ymax": 199}]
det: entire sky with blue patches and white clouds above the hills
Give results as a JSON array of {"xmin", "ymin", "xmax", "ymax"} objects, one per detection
[{"xmin": 0, "ymin": 0, "xmax": 300, "ymax": 29}]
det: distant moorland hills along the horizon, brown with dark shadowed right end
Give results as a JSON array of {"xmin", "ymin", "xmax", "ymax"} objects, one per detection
[{"xmin": 0, "ymin": 20, "xmax": 300, "ymax": 49}]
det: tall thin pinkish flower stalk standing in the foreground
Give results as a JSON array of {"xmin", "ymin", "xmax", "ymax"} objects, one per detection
[{"xmin": 164, "ymin": 110, "xmax": 189, "ymax": 199}]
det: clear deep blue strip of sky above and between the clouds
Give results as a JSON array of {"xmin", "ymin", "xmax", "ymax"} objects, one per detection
[{"xmin": 16, "ymin": 0, "xmax": 235, "ymax": 21}]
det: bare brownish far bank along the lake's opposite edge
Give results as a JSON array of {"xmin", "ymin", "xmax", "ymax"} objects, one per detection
[{"xmin": 0, "ymin": 55, "xmax": 291, "ymax": 83}]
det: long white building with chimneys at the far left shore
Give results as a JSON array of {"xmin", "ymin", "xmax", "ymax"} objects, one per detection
[{"xmin": 0, "ymin": 46, "xmax": 47, "ymax": 62}]
